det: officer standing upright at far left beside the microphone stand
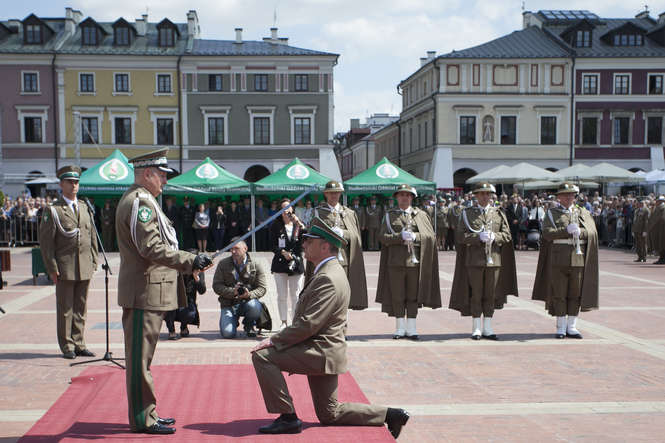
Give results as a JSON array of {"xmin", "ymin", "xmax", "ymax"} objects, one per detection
[{"xmin": 39, "ymin": 166, "xmax": 97, "ymax": 359}]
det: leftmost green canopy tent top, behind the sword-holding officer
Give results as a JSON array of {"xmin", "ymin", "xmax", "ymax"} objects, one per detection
[{"xmin": 79, "ymin": 149, "xmax": 134, "ymax": 197}]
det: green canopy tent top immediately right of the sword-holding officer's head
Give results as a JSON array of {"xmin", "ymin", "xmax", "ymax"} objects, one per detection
[{"xmin": 164, "ymin": 157, "xmax": 252, "ymax": 201}]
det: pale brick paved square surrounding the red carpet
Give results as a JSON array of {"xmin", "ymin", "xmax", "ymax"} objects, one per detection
[{"xmin": 0, "ymin": 248, "xmax": 665, "ymax": 443}]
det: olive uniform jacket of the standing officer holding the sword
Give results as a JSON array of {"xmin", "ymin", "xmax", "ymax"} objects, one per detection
[{"xmin": 115, "ymin": 184, "xmax": 196, "ymax": 311}]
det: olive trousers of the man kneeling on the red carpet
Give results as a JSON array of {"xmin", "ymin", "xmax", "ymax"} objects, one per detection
[{"xmin": 252, "ymin": 344, "xmax": 388, "ymax": 426}]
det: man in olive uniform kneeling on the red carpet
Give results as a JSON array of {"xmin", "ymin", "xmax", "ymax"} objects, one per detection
[{"xmin": 252, "ymin": 217, "xmax": 409, "ymax": 438}]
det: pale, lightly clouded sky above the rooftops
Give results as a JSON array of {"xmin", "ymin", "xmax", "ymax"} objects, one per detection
[{"xmin": 5, "ymin": 0, "xmax": 665, "ymax": 132}]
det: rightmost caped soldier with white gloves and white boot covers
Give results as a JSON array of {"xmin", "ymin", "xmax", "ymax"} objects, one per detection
[{"xmin": 531, "ymin": 183, "xmax": 598, "ymax": 339}]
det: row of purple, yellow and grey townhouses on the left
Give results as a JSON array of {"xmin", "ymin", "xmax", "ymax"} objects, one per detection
[{"xmin": 0, "ymin": 8, "xmax": 341, "ymax": 194}]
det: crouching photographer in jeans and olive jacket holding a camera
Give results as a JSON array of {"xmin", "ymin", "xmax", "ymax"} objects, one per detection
[{"xmin": 212, "ymin": 240, "xmax": 268, "ymax": 338}]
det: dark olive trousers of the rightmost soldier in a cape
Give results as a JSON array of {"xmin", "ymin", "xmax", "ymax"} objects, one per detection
[{"xmin": 549, "ymin": 266, "xmax": 584, "ymax": 317}]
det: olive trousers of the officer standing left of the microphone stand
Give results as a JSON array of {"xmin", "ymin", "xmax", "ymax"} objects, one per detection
[{"xmin": 55, "ymin": 280, "xmax": 90, "ymax": 354}]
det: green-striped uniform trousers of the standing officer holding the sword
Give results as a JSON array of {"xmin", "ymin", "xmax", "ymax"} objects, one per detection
[{"xmin": 122, "ymin": 308, "xmax": 166, "ymax": 431}]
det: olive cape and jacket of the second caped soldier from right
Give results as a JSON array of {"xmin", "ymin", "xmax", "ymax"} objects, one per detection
[{"xmin": 448, "ymin": 207, "xmax": 519, "ymax": 316}]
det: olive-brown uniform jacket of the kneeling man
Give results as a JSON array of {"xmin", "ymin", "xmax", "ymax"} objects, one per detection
[{"xmin": 270, "ymin": 258, "xmax": 351, "ymax": 375}]
